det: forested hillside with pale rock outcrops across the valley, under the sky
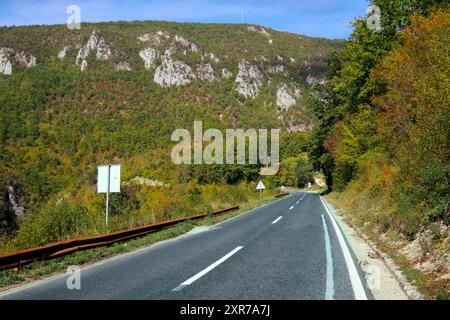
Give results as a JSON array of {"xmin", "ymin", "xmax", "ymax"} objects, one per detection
[{"xmin": 0, "ymin": 22, "xmax": 343, "ymax": 251}]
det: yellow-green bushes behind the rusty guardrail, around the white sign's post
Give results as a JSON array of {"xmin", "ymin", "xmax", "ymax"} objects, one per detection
[{"xmin": 3, "ymin": 183, "xmax": 277, "ymax": 252}]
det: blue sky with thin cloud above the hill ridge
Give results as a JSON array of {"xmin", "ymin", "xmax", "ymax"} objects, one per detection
[{"xmin": 0, "ymin": 0, "xmax": 368, "ymax": 38}]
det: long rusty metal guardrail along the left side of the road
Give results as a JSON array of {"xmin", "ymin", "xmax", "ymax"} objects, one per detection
[{"xmin": 0, "ymin": 206, "xmax": 239, "ymax": 270}]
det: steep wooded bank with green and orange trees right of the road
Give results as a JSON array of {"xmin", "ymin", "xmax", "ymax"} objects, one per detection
[{"xmin": 309, "ymin": 0, "xmax": 450, "ymax": 297}]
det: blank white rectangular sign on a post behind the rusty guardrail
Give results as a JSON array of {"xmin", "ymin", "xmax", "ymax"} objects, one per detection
[{"xmin": 97, "ymin": 164, "xmax": 120, "ymax": 225}]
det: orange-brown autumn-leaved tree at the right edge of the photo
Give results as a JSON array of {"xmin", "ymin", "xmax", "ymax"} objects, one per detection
[{"xmin": 372, "ymin": 9, "xmax": 450, "ymax": 220}]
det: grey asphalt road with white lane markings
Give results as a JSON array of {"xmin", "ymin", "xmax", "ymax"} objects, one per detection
[{"xmin": 0, "ymin": 192, "xmax": 370, "ymax": 300}]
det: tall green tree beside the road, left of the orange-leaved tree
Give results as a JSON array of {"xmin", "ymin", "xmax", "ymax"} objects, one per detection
[{"xmin": 307, "ymin": 0, "xmax": 446, "ymax": 188}]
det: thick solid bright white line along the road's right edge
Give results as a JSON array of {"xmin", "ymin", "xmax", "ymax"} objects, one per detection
[{"xmin": 319, "ymin": 196, "xmax": 367, "ymax": 300}]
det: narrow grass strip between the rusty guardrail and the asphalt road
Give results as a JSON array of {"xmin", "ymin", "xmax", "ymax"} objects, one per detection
[{"xmin": 0, "ymin": 194, "xmax": 274, "ymax": 291}]
